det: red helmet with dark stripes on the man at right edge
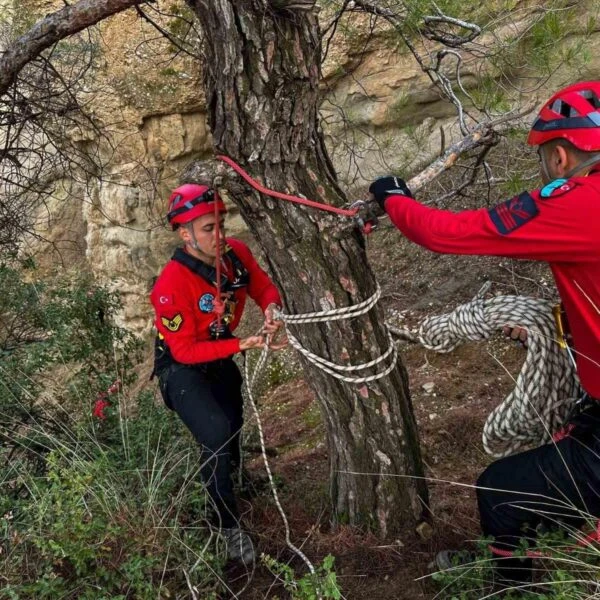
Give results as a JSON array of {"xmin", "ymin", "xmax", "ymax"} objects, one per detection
[{"xmin": 527, "ymin": 81, "xmax": 600, "ymax": 152}]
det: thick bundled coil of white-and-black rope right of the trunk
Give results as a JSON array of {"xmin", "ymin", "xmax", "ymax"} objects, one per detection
[{"xmin": 400, "ymin": 286, "xmax": 582, "ymax": 458}]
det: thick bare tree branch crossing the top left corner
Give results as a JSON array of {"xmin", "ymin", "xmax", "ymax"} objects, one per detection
[{"xmin": 0, "ymin": 0, "xmax": 140, "ymax": 95}]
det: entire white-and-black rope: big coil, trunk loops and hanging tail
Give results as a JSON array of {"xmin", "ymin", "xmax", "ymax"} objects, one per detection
[{"xmin": 244, "ymin": 284, "xmax": 582, "ymax": 599}]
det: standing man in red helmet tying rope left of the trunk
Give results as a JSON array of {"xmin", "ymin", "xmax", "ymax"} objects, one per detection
[{"xmin": 150, "ymin": 183, "xmax": 281, "ymax": 564}]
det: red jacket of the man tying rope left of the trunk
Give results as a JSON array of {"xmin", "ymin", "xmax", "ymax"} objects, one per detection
[{"xmin": 150, "ymin": 238, "xmax": 281, "ymax": 364}]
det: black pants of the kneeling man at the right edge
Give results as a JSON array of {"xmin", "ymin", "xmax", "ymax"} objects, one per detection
[{"xmin": 477, "ymin": 404, "xmax": 600, "ymax": 581}]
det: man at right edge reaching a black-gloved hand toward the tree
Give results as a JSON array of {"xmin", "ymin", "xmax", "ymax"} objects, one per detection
[{"xmin": 369, "ymin": 81, "xmax": 600, "ymax": 581}]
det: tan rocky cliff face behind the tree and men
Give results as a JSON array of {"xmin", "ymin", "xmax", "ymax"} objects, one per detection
[{"xmin": 11, "ymin": 0, "xmax": 600, "ymax": 334}]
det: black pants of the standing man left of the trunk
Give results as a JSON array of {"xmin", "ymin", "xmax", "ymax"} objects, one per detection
[{"xmin": 160, "ymin": 359, "xmax": 243, "ymax": 527}]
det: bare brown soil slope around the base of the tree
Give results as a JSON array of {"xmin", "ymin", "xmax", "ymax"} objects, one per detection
[{"xmin": 219, "ymin": 219, "xmax": 552, "ymax": 600}]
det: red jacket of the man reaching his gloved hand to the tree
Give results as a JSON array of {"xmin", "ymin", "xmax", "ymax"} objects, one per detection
[{"xmin": 385, "ymin": 169, "xmax": 600, "ymax": 398}]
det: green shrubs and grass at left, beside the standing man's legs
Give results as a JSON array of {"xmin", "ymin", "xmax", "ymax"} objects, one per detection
[{"xmin": 0, "ymin": 266, "xmax": 223, "ymax": 600}]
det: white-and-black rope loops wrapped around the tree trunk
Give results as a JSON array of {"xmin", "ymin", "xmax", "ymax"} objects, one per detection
[{"xmin": 274, "ymin": 285, "xmax": 398, "ymax": 384}]
